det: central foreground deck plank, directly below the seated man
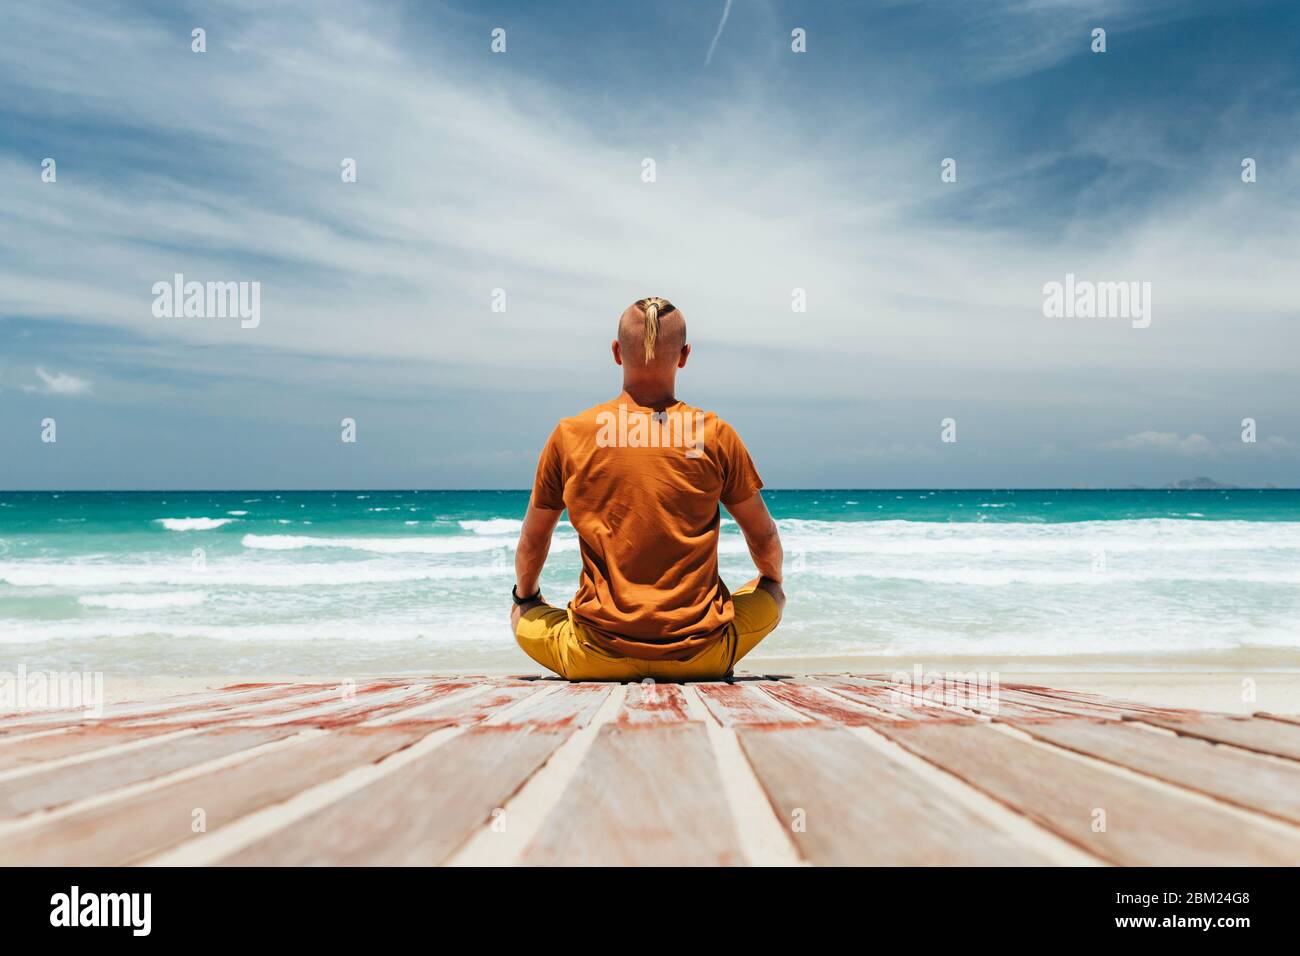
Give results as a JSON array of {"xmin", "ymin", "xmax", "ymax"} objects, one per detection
[{"xmin": 523, "ymin": 721, "xmax": 745, "ymax": 866}]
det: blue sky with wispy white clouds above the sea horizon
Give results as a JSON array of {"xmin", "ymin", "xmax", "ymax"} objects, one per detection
[{"xmin": 0, "ymin": 0, "xmax": 1300, "ymax": 488}]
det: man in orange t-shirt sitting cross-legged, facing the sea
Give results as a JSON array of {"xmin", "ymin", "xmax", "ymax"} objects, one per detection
[{"xmin": 510, "ymin": 298, "xmax": 785, "ymax": 680}]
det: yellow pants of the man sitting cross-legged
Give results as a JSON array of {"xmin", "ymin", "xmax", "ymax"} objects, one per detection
[{"xmin": 515, "ymin": 588, "xmax": 781, "ymax": 682}]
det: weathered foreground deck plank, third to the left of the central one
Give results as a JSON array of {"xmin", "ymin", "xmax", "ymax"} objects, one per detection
[{"xmin": 0, "ymin": 728, "xmax": 293, "ymax": 819}]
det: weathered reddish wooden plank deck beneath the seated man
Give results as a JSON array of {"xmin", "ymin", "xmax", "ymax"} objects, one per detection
[{"xmin": 0, "ymin": 675, "xmax": 1300, "ymax": 866}]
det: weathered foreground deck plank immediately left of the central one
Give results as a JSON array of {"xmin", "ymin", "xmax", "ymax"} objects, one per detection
[{"xmin": 220, "ymin": 724, "xmax": 573, "ymax": 866}]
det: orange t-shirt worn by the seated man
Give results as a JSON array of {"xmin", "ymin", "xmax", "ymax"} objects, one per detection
[{"xmin": 533, "ymin": 394, "xmax": 763, "ymax": 661}]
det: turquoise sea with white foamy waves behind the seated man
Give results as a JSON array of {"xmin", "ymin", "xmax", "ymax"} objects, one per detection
[{"xmin": 0, "ymin": 490, "xmax": 1300, "ymax": 675}]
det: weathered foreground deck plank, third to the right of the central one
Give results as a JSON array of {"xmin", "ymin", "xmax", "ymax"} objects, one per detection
[{"xmin": 1019, "ymin": 721, "xmax": 1300, "ymax": 823}]
